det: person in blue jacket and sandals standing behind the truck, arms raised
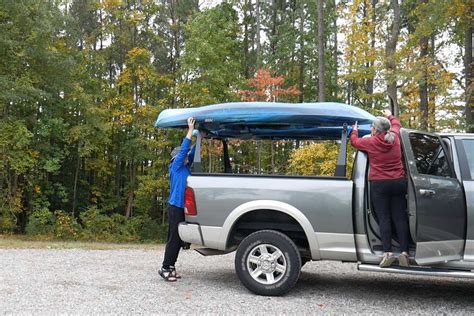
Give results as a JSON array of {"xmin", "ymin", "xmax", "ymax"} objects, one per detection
[{"xmin": 159, "ymin": 117, "xmax": 195, "ymax": 282}]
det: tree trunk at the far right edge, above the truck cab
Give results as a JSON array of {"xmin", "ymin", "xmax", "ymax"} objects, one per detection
[{"xmin": 464, "ymin": 27, "xmax": 474, "ymax": 133}]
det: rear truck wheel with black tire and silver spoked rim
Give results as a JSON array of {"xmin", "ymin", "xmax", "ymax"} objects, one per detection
[{"xmin": 235, "ymin": 230, "xmax": 301, "ymax": 296}]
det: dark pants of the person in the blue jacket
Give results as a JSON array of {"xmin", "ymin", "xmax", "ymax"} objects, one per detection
[{"xmin": 163, "ymin": 205, "xmax": 184, "ymax": 268}]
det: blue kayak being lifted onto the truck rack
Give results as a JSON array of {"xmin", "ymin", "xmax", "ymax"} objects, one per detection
[{"xmin": 155, "ymin": 102, "xmax": 375, "ymax": 139}]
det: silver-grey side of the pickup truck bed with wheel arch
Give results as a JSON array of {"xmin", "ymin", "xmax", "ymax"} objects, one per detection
[{"xmin": 180, "ymin": 174, "xmax": 356, "ymax": 260}]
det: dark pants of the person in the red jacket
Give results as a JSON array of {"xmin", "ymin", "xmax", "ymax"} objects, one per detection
[{"xmin": 370, "ymin": 179, "xmax": 410, "ymax": 252}]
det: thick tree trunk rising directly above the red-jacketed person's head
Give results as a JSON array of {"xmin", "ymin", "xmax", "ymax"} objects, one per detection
[{"xmin": 385, "ymin": 0, "xmax": 400, "ymax": 117}]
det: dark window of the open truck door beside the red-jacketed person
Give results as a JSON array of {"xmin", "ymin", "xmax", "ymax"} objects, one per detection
[{"xmin": 410, "ymin": 133, "xmax": 452, "ymax": 177}]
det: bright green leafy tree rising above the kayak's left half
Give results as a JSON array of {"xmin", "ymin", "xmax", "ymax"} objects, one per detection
[{"xmin": 179, "ymin": 3, "xmax": 243, "ymax": 106}]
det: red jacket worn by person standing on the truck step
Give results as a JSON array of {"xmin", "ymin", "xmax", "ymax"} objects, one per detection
[{"xmin": 350, "ymin": 115, "xmax": 405, "ymax": 180}]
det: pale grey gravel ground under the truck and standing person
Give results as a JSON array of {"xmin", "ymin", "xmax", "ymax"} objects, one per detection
[{"xmin": 0, "ymin": 247, "xmax": 474, "ymax": 314}]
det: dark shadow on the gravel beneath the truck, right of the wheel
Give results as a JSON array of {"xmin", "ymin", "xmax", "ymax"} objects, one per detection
[{"xmin": 289, "ymin": 271, "xmax": 474, "ymax": 307}]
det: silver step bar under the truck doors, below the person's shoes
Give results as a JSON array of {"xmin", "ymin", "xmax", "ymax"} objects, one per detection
[{"xmin": 357, "ymin": 264, "xmax": 474, "ymax": 279}]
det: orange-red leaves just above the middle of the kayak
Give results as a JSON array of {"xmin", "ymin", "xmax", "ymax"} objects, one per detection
[{"xmin": 238, "ymin": 69, "xmax": 301, "ymax": 102}]
